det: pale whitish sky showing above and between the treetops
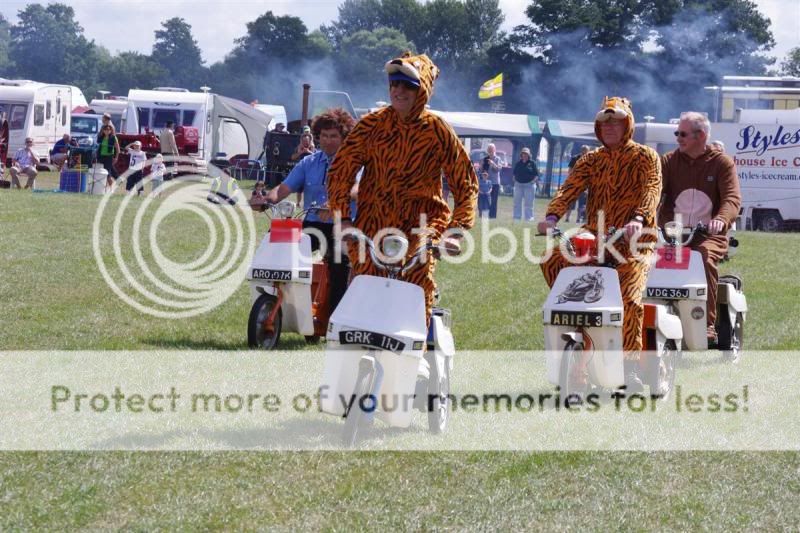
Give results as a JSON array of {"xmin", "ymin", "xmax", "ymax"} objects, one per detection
[{"xmin": 0, "ymin": 0, "xmax": 800, "ymax": 65}]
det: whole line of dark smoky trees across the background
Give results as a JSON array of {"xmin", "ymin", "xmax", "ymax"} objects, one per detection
[{"xmin": 0, "ymin": 0, "xmax": 800, "ymax": 120}]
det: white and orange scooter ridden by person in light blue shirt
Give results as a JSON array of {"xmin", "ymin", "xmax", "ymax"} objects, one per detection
[{"xmin": 247, "ymin": 201, "xmax": 329, "ymax": 350}]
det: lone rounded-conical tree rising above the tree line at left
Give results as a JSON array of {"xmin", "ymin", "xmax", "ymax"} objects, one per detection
[{"xmin": 152, "ymin": 17, "xmax": 208, "ymax": 90}]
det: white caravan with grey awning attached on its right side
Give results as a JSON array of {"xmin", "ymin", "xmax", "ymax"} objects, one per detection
[{"xmin": 122, "ymin": 87, "xmax": 272, "ymax": 161}]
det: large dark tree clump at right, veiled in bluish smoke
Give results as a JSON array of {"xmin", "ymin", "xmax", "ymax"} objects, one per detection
[{"xmin": 513, "ymin": 0, "xmax": 774, "ymax": 120}]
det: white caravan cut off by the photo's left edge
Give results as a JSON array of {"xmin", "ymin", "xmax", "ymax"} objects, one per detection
[{"xmin": 0, "ymin": 78, "xmax": 86, "ymax": 162}]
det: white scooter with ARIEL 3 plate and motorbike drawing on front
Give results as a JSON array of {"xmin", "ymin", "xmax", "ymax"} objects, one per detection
[{"xmin": 543, "ymin": 228, "xmax": 683, "ymax": 402}]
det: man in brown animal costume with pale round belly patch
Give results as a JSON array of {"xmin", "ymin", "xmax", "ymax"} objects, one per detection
[{"xmin": 658, "ymin": 111, "xmax": 742, "ymax": 345}]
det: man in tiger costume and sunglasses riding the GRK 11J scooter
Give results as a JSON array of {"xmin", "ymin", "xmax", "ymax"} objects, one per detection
[{"xmin": 328, "ymin": 52, "xmax": 478, "ymax": 319}]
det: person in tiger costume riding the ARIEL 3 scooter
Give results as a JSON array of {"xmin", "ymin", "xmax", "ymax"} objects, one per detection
[{"xmin": 539, "ymin": 96, "xmax": 661, "ymax": 393}]
